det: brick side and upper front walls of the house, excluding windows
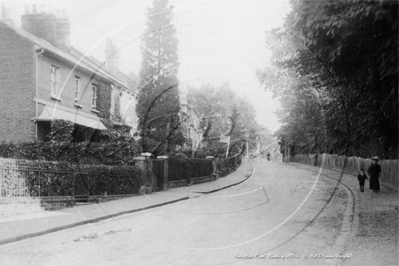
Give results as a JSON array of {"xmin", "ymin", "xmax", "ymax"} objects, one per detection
[{"xmin": 0, "ymin": 21, "xmax": 118, "ymax": 142}]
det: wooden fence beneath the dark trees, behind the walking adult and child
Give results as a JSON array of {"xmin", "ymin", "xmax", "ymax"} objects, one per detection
[{"xmin": 289, "ymin": 154, "xmax": 399, "ymax": 191}]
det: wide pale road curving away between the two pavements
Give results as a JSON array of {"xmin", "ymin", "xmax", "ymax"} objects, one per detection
[{"xmin": 0, "ymin": 162, "xmax": 348, "ymax": 265}]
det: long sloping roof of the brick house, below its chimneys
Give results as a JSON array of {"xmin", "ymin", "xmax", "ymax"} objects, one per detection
[{"xmin": 0, "ymin": 19, "xmax": 138, "ymax": 92}]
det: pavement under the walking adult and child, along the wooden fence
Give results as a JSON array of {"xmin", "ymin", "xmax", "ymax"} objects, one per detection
[{"xmin": 290, "ymin": 163, "xmax": 399, "ymax": 265}]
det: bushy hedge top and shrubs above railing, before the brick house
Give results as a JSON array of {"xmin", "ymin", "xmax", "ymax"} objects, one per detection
[{"xmin": 0, "ymin": 120, "xmax": 139, "ymax": 165}]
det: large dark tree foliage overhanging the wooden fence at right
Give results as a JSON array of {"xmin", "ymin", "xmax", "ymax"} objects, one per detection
[{"xmin": 258, "ymin": 0, "xmax": 398, "ymax": 158}]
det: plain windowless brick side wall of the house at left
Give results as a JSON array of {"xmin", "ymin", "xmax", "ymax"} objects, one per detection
[{"xmin": 0, "ymin": 21, "xmax": 36, "ymax": 142}]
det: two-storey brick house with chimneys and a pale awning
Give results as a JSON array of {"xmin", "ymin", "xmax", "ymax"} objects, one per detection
[{"xmin": 0, "ymin": 6, "xmax": 138, "ymax": 142}]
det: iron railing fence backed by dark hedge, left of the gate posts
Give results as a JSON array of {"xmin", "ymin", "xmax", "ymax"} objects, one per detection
[{"xmin": 0, "ymin": 158, "xmax": 143, "ymax": 197}]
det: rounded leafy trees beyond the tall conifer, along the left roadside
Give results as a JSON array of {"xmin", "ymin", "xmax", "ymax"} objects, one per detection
[{"xmin": 187, "ymin": 83, "xmax": 272, "ymax": 157}]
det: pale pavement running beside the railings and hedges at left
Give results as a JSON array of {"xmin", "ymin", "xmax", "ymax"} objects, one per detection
[{"xmin": 0, "ymin": 163, "xmax": 252, "ymax": 245}]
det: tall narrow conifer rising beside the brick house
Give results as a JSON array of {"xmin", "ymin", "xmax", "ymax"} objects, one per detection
[{"xmin": 136, "ymin": 0, "xmax": 184, "ymax": 154}]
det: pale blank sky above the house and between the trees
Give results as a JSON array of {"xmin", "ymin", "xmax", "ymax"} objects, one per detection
[{"xmin": 0, "ymin": 0, "xmax": 289, "ymax": 132}]
